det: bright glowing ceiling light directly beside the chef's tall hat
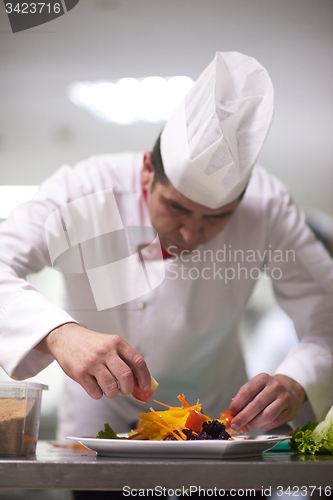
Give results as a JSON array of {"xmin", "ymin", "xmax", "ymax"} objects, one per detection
[{"xmin": 67, "ymin": 76, "xmax": 194, "ymax": 125}]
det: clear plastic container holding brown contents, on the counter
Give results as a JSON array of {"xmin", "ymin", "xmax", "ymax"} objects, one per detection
[{"xmin": 0, "ymin": 381, "xmax": 48, "ymax": 457}]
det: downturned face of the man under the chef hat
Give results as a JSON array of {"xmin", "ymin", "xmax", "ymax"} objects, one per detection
[{"xmin": 141, "ymin": 152, "xmax": 240, "ymax": 254}]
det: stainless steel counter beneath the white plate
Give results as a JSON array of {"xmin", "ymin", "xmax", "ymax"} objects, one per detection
[{"xmin": 0, "ymin": 441, "xmax": 333, "ymax": 490}]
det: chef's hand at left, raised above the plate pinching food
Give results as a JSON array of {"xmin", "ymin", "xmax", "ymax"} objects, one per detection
[{"xmin": 36, "ymin": 323, "xmax": 151, "ymax": 399}]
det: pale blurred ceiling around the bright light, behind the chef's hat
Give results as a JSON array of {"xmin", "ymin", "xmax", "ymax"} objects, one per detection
[{"xmin": 0, "ymin": 0, "xmax": 333, "ymax": 215}]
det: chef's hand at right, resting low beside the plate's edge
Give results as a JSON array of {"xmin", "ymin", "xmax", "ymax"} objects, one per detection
[{"xmin": 229, "ymin": 373, "xmax": 306, "ymax": 431}]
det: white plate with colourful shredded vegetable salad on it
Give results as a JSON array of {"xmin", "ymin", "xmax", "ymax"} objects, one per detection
[{"xmin": 68, "ymin": 394, "xmax": 289, "ymax": 459}]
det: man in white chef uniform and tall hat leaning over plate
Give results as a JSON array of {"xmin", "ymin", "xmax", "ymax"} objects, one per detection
[{"xmin": 0, "ymin": 52, "xmax": 333, "ymax": 440}]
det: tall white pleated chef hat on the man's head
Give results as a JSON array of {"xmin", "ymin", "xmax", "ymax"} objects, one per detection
[{"xmin": 161, "ymin": 52, "xmax": 274, "ymax": 209}]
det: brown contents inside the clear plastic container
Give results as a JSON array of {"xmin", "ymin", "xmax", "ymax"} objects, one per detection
[{"xmin": 0, "ymin": 398, "xmax": 35, "ymax": 455}]
